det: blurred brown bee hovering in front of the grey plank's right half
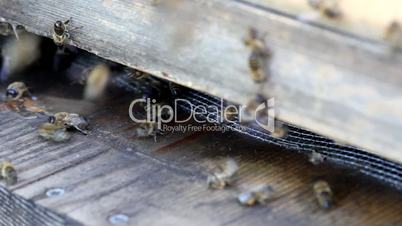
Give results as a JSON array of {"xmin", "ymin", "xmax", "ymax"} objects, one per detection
[{"xmin": 244, "ymin": 28, "xmax": 271, "ymax": 83}]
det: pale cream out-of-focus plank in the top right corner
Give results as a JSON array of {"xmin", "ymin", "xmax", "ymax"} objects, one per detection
[{"xmin": 240, "ymin": 0, "xmax": 402, "ymax": 42}]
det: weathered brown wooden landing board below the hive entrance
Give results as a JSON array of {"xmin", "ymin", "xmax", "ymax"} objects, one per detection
[{"xmin": 0, "ymin": 85, "xmax": 402, "ymax": 226}]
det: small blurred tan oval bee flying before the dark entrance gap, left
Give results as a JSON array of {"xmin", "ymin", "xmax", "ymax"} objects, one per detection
[{"xmin": 84, "ymin": 64, "xmax": 110, "ymax": 100}]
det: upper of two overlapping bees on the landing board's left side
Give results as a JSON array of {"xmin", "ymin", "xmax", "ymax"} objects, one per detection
[{"xmin": 48, "ymin": 112, "xmax": 89, "ymax": 135}]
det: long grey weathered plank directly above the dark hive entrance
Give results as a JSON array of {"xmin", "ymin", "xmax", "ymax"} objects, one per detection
[{"xmin": 0, "ymin": 0, "xmax": 402, "ymax": 162}]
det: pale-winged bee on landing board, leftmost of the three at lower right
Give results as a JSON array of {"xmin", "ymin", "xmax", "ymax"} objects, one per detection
[{"xmin": 207, "ymin": 159, "xmax": 239, "ymax": 189}]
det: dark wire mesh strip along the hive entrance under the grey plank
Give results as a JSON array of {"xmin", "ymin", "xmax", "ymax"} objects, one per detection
[{"xmin": 115, "ymin": 73, "xmax": 402, "ymax": 190}]
